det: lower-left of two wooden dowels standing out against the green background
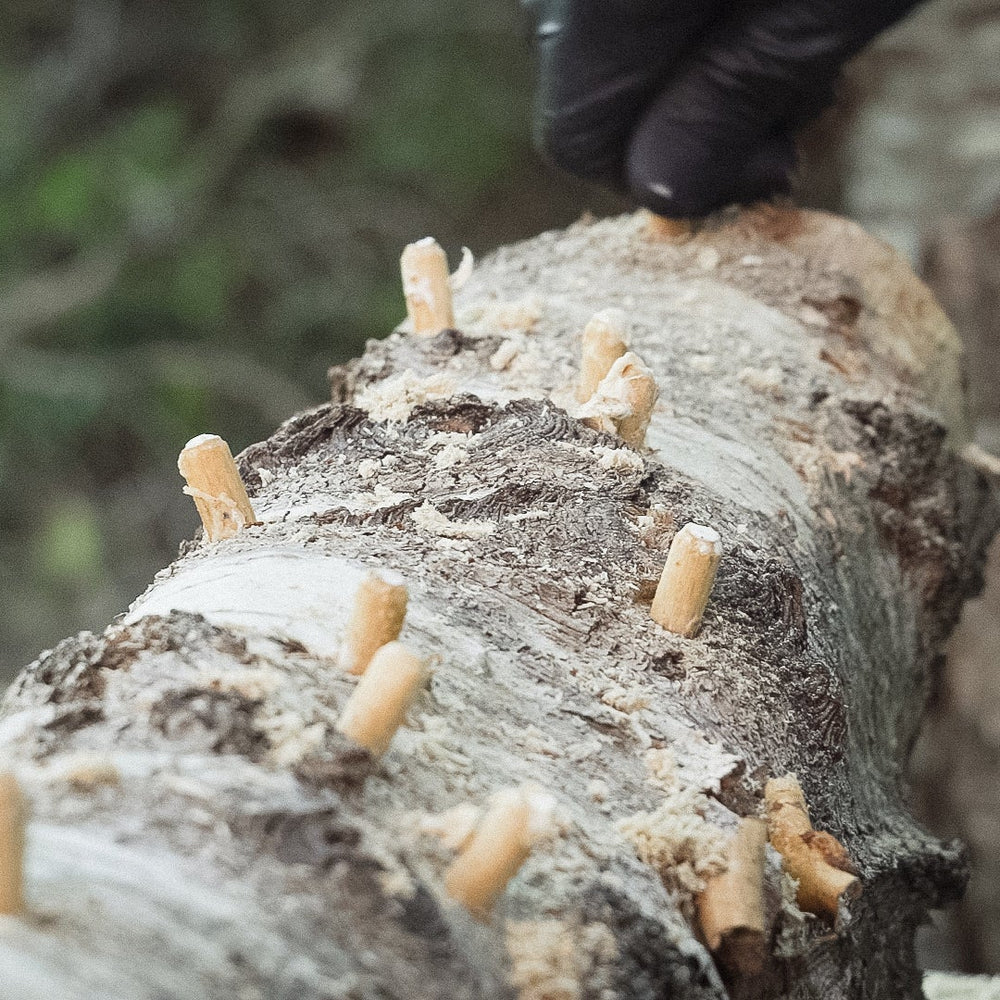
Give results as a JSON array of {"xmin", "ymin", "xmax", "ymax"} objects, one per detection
[{"xmin": 177, "ymin": 434, "xmax": 257, "ymax": 542}]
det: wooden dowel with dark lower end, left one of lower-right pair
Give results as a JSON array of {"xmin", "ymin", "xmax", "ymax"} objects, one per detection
[{"xmin": 697, "ymin": 819, "xmax": 767, "ymax": 976}]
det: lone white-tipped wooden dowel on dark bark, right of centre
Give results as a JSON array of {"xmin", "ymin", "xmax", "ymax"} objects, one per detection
[{"xmin": 650, "ymin": 524, "xmax": 722, "ymax": 638}]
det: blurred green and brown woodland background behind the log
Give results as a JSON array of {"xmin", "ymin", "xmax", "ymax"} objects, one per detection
[{"xmin": 0, "ymin": 0, "xmax": 1000, "ymax": 969}]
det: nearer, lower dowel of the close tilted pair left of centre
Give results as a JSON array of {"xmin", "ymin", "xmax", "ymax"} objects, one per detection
[{"xmin": 337, "ymin": 642, "xmax": 428, "ymax": 757}]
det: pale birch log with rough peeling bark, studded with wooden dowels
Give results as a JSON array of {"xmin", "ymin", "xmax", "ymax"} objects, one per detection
[{"xmin": 0, "ymin": 210, "xmax": 994, "ymax": 1000}]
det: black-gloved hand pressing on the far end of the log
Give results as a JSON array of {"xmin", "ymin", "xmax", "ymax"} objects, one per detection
[{"xmin": 526, "ymin": 0, "xmax": 919, "ymax": 217}]
